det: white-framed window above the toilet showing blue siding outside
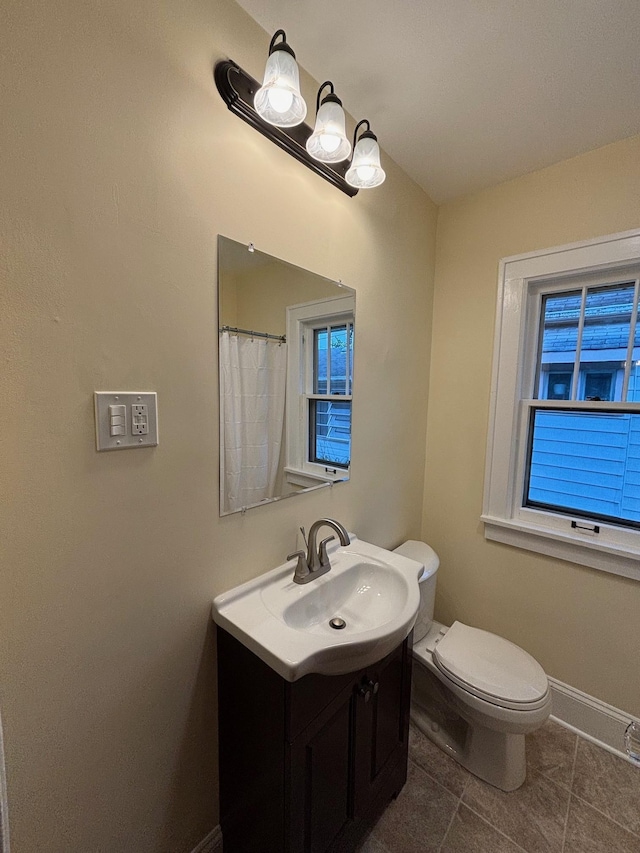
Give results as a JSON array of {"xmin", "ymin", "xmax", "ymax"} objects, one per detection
[{"xmin": 482, "ymin": 232, "xmax": 640, "ymax": 580}]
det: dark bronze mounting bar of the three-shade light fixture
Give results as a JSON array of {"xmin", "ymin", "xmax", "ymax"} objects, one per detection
[{"xmin": 213, "ymin": 59, "xmax": 358, "ymax": 196}]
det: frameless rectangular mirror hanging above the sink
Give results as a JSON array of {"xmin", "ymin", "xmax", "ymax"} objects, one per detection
[{"xmin": 218, "ymin": 236, "xmax": 355, "ymax": 515}]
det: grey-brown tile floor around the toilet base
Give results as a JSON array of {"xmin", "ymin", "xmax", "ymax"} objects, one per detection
[{"xmin": 359, "ymin": 721, "xmax": 640, "ymax": 853}]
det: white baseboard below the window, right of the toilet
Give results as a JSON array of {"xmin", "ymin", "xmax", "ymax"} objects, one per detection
[{"xmin": 549, "ymin": 677, "xmax": 640, "ymax": 764}]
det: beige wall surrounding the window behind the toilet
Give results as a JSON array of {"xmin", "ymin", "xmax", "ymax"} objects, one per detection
[{"xmin": 423, "ymin": 137, "xmax": 640, "ymax": 715}]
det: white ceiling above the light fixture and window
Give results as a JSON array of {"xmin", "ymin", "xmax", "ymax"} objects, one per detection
[{"xmin": 231, "ymin": 0, "xmax": 640, "ymax": 203}]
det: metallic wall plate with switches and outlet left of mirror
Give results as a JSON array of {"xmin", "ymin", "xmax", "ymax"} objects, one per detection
[{"xmin": 94, "ymin": 391, "xmax": 158, "ymax": 450}]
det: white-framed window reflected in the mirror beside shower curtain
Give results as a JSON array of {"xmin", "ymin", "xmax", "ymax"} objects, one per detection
[{"xmin": 285, "ymin": 296, "xmax": 355, "ymax": 486}]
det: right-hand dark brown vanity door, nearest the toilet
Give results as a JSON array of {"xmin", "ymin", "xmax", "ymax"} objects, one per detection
[{"xmin": 354, "ymin": 642, "xmax": 411, "ymax": 817}]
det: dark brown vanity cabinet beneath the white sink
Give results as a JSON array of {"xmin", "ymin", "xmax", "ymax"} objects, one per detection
[{"xmin": 218, "ymin": 628, "xmax": 411, "ymax": 853}]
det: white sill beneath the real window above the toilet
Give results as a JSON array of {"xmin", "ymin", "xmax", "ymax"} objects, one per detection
[{"xmin": 480, "ymin": 515, "xmax": 640, "ymax": 581}]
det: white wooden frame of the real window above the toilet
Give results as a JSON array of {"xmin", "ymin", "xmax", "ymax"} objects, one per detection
[{"xmin": 481, "ymin": 230, "xmax": 640, "ymax": 580}]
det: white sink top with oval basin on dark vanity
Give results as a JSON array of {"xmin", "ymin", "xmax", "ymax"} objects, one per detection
[{"xmin": 213, "ymin": 538, "xmax": 422, "ymax": 681}]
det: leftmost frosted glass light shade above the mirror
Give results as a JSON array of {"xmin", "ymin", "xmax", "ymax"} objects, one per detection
[{"xmin": 253, "ymin": 49, "xmax": 307, "ymax": 127}]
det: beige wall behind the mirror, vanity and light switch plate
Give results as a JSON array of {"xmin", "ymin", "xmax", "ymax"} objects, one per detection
[{"xmin": 0, "ymin": 0, "xmax": 436, "ymax": 853}]
